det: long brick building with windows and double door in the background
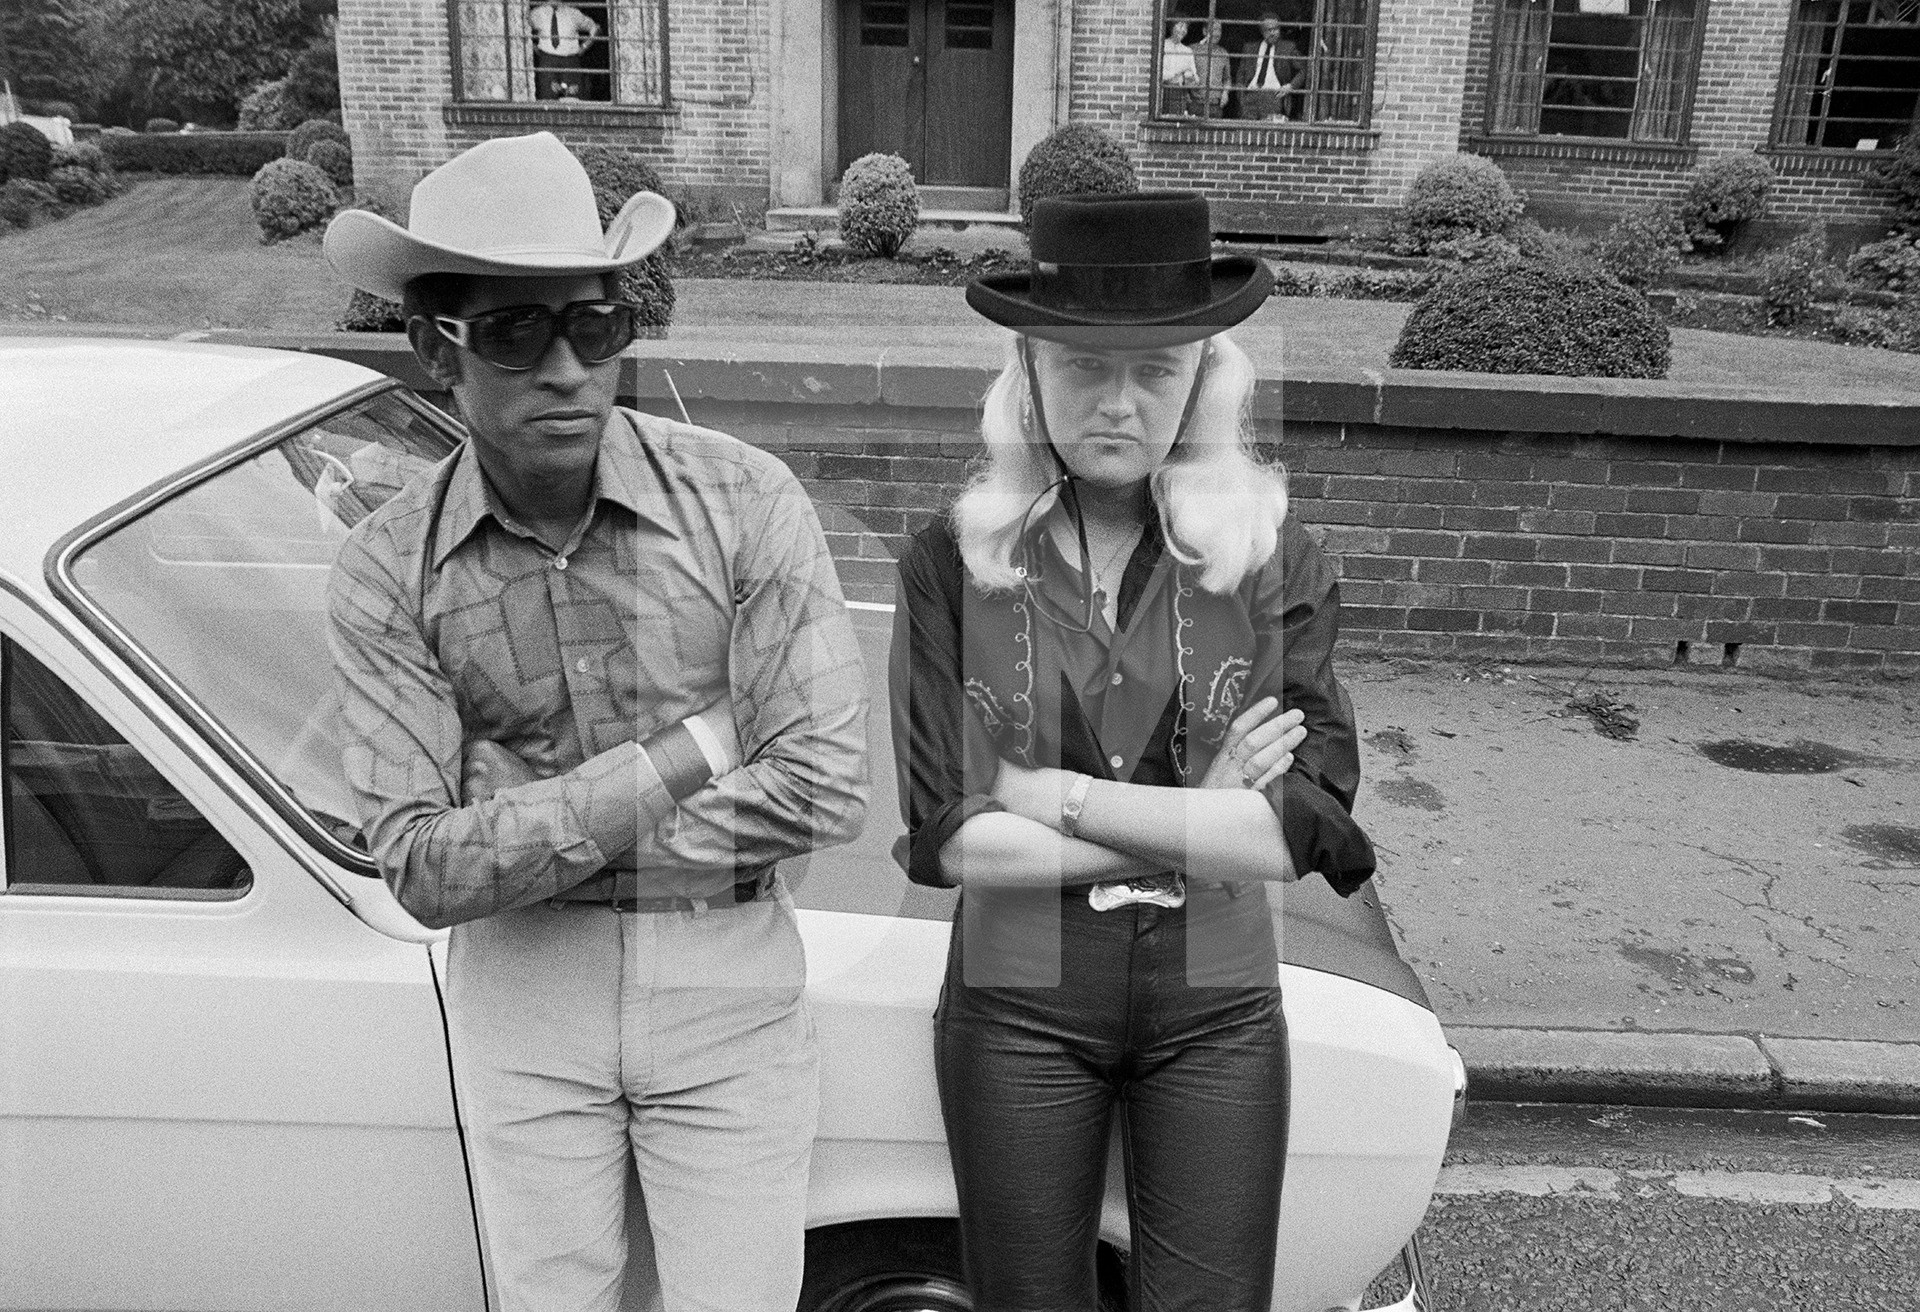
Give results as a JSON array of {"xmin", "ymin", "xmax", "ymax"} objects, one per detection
[{"xmin": 338, "ymin": 0, "xmax": 1920, "ymax": 234}]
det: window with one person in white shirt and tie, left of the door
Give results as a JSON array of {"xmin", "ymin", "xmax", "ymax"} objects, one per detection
[{"xmin": 449, "ymin": 0, "xmax": 666, "ymax": 108}]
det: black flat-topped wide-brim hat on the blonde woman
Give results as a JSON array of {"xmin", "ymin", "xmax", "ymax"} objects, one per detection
[{"xmin": 966, "ymin": 192, "xmax": 1273, "ymax": 350}]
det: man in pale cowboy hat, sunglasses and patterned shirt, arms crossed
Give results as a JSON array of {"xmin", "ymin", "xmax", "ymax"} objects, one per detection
[{"xmin": 324, "ymin": 133, "xmax": 866, "ymax": 1312}]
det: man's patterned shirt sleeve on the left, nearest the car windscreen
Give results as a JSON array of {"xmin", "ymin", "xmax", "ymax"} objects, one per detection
[{"xmin": 328, "ymin": 534, "xmax": 674, "ymax": 928}]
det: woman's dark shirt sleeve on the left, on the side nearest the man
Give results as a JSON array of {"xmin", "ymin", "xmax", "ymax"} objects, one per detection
[{"xmin": 887, "ymin": 532, "xmax": 1004, "ymax": 887}]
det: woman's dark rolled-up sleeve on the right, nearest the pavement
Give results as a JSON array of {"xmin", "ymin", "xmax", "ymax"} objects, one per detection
[{"xmin": 1248, "ymin": 519, "xmax": 1375, "ymax": 897}]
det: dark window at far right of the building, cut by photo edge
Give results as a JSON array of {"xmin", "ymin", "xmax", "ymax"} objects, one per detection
[{"xmin": 1774, "ymin": 0, "xmax": 1920, "ymax": 150}]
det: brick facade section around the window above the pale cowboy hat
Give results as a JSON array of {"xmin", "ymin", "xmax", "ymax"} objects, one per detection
[{"xmin": 336, "ymin": 0, "xmax": 774, "ymax": 213}]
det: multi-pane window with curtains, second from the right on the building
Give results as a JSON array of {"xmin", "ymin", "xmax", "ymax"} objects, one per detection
[{"xmin": 1488, "ymin": 0, "xmax": 1707, "ymax": 142}]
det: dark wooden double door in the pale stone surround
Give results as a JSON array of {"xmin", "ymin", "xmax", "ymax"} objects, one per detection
[{"xmin": 839, "ymin": 0, "xmax": 1014, "ymax": 186}]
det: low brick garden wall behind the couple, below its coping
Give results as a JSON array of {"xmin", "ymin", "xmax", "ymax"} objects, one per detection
[{"xmin": 637, "ymin": 401, "xmax": 1920, "ymax": 674}]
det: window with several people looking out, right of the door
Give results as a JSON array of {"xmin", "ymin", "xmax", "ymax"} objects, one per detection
[{"xmin": 1154, "ymin": 0, "xmax": 1379, "ymax": 127}]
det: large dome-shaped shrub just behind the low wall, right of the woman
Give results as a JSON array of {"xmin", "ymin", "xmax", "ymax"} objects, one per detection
[{"xmin": 1388, "ymin": 259, "xmax": 1670, "ymax": 378}]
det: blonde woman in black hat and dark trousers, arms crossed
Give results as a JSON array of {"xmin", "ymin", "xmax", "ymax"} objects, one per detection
[{"xmin": 891, "ymin": 192, "xmax": 1373, "ymax": 1312}]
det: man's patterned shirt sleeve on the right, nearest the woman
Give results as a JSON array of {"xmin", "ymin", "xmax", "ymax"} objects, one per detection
[{"xmin": 618, "ymin": 457, "xmax": 866, "ymax": 868}]
